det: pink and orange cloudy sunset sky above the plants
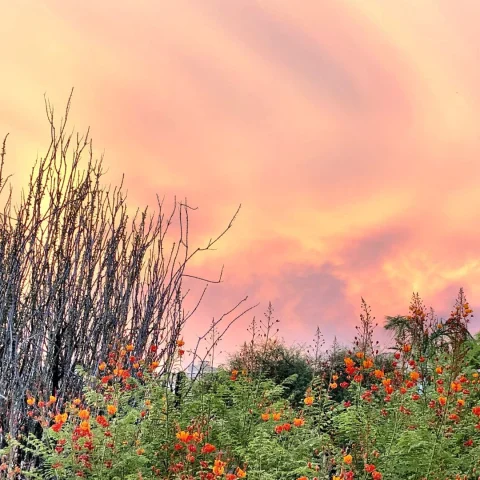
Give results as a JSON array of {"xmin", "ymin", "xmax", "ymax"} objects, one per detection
[{"xmin": 0, "ymin": 0, "xmax": 480, "ymax": 360}]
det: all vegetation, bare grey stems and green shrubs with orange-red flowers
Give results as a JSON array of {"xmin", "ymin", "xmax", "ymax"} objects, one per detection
[{"xmin": 0, "ymin": 99, "xmax": 480, "ymax": 480}]
